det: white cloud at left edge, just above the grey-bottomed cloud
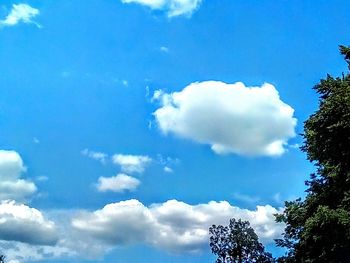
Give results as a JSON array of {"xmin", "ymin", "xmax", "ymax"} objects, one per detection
[{"xmin": 0, "ymin": 150, "xmax": 37, "ymax": 200}]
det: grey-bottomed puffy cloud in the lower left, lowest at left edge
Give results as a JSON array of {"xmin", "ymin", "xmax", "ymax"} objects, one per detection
[{"xmin": 0, "ymin": 201, "xmax": 58, "ymax": 245}]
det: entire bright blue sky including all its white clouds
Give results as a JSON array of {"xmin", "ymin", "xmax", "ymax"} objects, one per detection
[{"xmin": 0, "ymin": 0, "xmax": 350, "ymax": 263}]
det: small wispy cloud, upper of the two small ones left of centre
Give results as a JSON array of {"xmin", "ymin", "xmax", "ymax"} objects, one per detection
[{"xmin": 112, "ymin": 154, "xmax": 152, "ymax": 173}]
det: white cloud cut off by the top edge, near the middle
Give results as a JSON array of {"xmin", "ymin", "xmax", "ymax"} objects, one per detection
[{"xmin": 121, "ymin": 0, "xmax": 202, "ymax": 17}]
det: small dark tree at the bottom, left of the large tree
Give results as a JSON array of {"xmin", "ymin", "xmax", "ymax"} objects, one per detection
[{"xmin": 209, "ymin": 219, "xmax": 274, "ymax": 263}]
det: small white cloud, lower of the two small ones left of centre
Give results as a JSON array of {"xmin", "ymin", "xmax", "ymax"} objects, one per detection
[{"xmin": 97, "ymin": 174, "xmax": 141, "ymax": 192}]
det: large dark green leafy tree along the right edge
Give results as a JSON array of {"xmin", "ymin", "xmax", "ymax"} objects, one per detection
[{"xmin": 276, "ymin": 46, "xmax": 350, "ymax": 263}]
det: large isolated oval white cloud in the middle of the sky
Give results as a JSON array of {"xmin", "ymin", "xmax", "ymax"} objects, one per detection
[{"xmin": 153, "ymin": 81, "xmax": 297, "ymax": 156}]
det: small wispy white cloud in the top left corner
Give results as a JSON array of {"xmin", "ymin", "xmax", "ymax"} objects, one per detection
[{"xmin": 0, "ymin": 4, "xmax": 40, "ymax": 27}]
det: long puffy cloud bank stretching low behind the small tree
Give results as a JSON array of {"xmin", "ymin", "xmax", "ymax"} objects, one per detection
[{"xmin": 72, "ymin": 200, "xmax": 283, "ymax": 253}]
